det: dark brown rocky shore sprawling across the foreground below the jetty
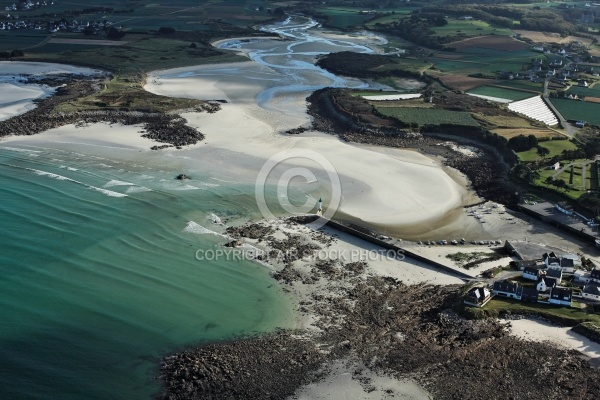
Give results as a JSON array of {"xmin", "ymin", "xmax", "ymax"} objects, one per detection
[{"xmin": 158, "ymin": 219, "xmax": 600, "ymax": 400}]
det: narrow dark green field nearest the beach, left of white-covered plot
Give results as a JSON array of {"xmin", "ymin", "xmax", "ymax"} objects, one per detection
[{"xmin": 376, "ymin": 107, "xmax": 479, "ymax": 126}]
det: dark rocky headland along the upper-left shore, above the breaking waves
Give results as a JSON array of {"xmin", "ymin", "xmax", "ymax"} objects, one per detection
[{"xmin": 0, "ymin": 74, "xmax": 221, "ymax": 150}]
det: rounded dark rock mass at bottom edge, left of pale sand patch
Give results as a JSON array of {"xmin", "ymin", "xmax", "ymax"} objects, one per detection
[{"xmin": 161, "ymin": 332, "xmax": 326, "ymax": 400}]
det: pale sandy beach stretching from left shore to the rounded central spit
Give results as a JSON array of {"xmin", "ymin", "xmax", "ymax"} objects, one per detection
[{"xmin": 3, "ymin": 55, "xmax": 477, "ymax": 238}]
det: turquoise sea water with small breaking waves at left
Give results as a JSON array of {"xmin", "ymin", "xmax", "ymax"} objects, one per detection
[{"xmin": 0, "ymin": 146, "xmax": 290, "ymax": 399}]
